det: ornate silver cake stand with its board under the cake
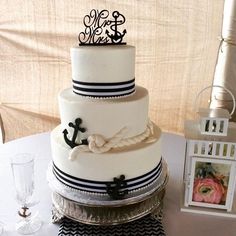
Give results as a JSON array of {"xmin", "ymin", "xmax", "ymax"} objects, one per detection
[{"xmin": 47, "ymin": 161, "xmax": 168, "ymax": 225}]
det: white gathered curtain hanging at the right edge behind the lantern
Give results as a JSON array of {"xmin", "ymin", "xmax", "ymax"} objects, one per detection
[{"xmin": 211, "ymin": 0, "xmax": 236, "ymax": 121}]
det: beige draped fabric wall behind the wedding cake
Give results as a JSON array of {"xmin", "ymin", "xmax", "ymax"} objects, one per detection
[{"xmin": 0, "ymin": 0, "xmax": 224, "ymax": 141}]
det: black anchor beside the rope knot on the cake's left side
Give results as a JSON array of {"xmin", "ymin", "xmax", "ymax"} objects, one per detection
[{"xmin": 63, "ymin": 118, "xmax": 88, "ymax": 148}]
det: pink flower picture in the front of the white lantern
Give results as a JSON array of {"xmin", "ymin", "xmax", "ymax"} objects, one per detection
[{"xmin": 192, "ymin": 161, "xmax": 231, "ymax": 205}]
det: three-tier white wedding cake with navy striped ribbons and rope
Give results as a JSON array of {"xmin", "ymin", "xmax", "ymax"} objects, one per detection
[{"xmin": 51, "ymin": 45, "xmax": 162, "ymax": 197}]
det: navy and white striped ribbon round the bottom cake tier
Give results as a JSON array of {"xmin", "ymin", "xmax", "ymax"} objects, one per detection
[{"xmin": 53, "ymin": 160, "xmax": 162, "ymax": 194}]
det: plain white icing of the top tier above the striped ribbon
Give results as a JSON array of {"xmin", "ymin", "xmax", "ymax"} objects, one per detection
[{"xmin": 70, "ymin": 45, "xmax": 135, "ymax": 83}]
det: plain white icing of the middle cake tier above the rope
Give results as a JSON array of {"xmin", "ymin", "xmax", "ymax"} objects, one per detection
[{"xmin": 59, "ymin": 86, "xmax": 148, "ymax": 138}]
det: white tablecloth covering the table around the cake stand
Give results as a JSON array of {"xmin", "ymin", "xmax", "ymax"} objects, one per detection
[{"xmin": 0, "ymin": 133, "xmax": 236, "ymax": 236}]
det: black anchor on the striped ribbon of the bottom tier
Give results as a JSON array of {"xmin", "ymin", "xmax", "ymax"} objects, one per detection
[{"xmin": 106, "ymin": 175, "xmax": 128, "ymax": 200}]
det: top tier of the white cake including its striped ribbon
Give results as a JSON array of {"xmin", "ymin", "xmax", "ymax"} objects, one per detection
[{"xmin": 71, "ymin": 45, "xmax": 135, "ymax": 97}]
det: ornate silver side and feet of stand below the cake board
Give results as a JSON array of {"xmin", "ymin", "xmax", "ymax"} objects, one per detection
[{"xmin": 52, "ymin": 183, "xmax": 165, "ymax": 225}]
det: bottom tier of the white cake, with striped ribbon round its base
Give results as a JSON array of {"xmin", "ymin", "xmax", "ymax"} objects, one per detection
[{"xmin": 51, "ymin": 123, "xmax": 163, "ymax": 194}]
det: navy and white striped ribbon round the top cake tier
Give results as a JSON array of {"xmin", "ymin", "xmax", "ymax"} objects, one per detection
[{"xmin": 72, "ymin": 79, "xmax": 135, "ymax": 97}]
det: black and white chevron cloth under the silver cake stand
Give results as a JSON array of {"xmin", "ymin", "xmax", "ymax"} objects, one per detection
[{"xmin": 58, "ymin": 215, "xmax": 165, "ymax": 236}]
